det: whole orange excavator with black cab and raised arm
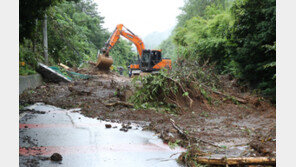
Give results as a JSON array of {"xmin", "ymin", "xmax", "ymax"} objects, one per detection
[{"xmin": 96, "ymin": 24, "xmax": 172, "ymax": 75}]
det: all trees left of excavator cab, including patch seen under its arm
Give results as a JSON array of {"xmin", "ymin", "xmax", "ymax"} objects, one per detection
[{"xmin": 20, "ymin": 0, "xmax": 135, "ymax": 74}]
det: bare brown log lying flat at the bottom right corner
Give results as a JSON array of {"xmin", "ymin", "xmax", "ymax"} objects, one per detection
[{"xmin": 194, "ymin": 157, "xmax": 276, "ymax": 165}]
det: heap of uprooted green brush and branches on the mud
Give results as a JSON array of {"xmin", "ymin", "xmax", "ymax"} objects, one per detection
[{"xmin": 131, "ymin": 59, "xmax": 219, "ymax": 114}]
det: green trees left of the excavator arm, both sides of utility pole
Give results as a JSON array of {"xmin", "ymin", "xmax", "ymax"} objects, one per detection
[{"xmin": 20, "ymin": 0, "xmax": 117, "ymax": 74}]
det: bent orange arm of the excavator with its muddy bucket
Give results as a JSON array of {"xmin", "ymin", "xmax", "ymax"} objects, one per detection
[{"xmin": 97, "ymin": 24, "xmax": 145, "ymax": 69}]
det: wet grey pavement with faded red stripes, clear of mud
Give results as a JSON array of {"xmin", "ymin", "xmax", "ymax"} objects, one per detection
[{"xmin": 19, "ymin": 103, "xmax": 185, "ymax": 167}]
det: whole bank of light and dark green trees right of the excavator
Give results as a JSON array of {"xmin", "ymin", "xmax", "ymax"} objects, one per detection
[{"xmin": 160, "ymin": 0, "xmax": 276, "ymax": 100}]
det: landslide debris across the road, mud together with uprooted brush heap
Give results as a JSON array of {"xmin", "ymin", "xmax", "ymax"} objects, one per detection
[{"xmin": 20, "ymin": 62, "xmax": 276, "ymax": 166}]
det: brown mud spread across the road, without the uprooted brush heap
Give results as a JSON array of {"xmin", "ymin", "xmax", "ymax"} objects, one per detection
[{"xmin": 20, "ymin": 65, "xmax": 276, "ymax": 166}]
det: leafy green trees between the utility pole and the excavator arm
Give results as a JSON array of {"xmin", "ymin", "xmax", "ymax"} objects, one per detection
[{"xmin": 48, "ymin": 0, "xmax": 107, "ymax": 67}]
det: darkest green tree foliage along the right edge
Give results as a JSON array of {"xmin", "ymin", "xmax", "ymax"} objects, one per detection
[{"xmin": 231, "ymin": 0, "xmax": 276, "ymax": 100}]
